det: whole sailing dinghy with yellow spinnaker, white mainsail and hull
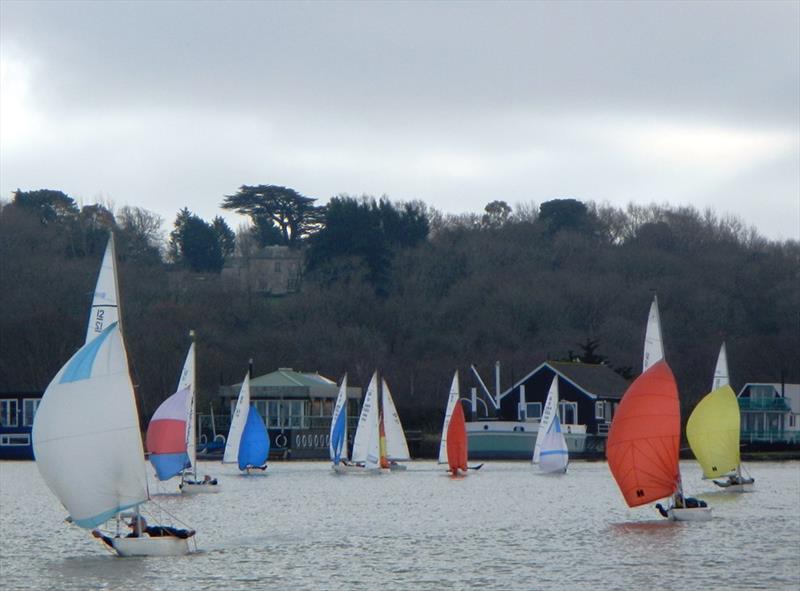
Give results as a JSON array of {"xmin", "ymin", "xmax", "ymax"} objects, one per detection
[{"xmin": 686, "ymin": 343, "xmax": 755, "ymax": 492}]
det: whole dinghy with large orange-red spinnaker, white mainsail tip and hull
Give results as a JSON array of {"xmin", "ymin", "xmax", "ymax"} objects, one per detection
[{"xmin": 606, "ymin": 298, "xmax": 711, "ymax": 521}]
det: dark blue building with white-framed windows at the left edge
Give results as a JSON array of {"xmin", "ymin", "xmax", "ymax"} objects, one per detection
[{"xmin": 0, "ymin": 392, "xmax": 43, "ymax": 460}]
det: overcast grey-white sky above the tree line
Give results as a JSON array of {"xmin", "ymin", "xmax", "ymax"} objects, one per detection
[{"xmin": 0, "ymin": 0, "xmax": 800, "ymax": 239}]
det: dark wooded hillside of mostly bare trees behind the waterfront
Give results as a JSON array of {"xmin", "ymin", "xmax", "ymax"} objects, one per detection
[{"xmin": 0, "ymin": 192, "xmax": 800, "ymax": 430}]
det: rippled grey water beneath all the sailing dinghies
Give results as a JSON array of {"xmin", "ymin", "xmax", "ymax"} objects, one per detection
[{"xmin": 0, "ymin": 462, "xmax": 800, "ymax": 591}]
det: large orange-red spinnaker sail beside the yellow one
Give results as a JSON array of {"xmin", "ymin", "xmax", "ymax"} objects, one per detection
[{"xmin": 606, "ymin": 361, "xmax": 681, "ymax": 507}]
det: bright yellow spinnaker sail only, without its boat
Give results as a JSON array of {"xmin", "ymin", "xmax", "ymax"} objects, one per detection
[{"xmin": 686, "ymin": 385, "xmax": 741, "ymax": 478}]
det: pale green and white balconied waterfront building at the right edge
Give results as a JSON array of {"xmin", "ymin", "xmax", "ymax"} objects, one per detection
[{"xmin": 738, "ymin": 383, "xmax": 800, "ymax": 444}]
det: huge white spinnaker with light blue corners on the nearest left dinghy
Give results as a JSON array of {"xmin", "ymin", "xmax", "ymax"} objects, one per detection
[{"xmin": 33, "ymin": 324, "xmax": 147, "ymax": 528}]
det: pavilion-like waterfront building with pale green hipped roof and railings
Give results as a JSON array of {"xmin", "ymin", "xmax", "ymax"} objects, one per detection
[{"xmin": 216, "ymin": 367, "xmax": 361, "ymax": 459}]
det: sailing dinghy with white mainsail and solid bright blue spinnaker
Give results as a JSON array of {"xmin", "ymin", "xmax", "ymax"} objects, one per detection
[{"xmin": 222, "ymin": 372, "xmax": 269, "ymax": 474}]
